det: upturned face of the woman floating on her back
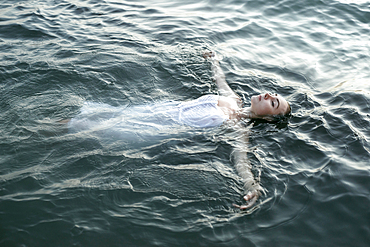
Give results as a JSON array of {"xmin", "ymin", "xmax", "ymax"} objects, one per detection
[{"xmin": 251, "ymin": 93, "xmax": 288, "ymax": 116}]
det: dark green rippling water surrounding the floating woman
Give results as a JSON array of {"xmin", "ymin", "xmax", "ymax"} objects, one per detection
[{"xmin": 0, "ymin": 0, "xmax": 370, "ymax": 246}]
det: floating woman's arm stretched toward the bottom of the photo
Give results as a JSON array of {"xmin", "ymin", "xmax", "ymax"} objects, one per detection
[{"xmin": 233, "ymin": 125, "xmax": 262, "ymax": 210}]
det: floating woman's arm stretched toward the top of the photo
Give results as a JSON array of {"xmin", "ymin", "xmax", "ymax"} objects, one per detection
[{"xmin": 203, "ymin": 52, "xmax": 241, "ymax": 103}]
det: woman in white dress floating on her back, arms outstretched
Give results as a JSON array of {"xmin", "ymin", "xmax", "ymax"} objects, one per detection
[{"xmin": 68, "ymin": 52, "xmax": 290, "ymax": 209}]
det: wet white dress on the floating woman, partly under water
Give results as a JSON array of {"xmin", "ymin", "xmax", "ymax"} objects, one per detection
[{"xmin": 68, "ymin": 95, "xmax": 228, "ymax": 141}]
